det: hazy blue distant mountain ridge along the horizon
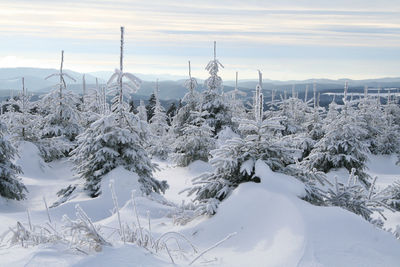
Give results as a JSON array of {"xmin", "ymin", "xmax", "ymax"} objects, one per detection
[{"xmin": 0, "ymin": 68, "xmax": 400, "ymax": 100}]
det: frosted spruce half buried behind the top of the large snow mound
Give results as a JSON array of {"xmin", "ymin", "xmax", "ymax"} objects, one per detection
[{"xmin": 186, "ymin": 73, "xmax": 293, "ymax": 215}]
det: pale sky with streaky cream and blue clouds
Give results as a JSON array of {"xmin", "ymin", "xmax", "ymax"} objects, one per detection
[{"xmin": 0, "ymin": 0, "xmax": 400, "ymax": 80}]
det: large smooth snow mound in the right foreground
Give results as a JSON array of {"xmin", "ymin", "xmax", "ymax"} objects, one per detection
[{"xmin": 184, "ymin": 161, "xmax": 400, "ymax": 267}]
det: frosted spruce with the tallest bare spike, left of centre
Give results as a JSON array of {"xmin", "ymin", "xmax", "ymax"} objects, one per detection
[{"xmin": 72, "ymin": 27, "xmax": 168, "ymax": 197}]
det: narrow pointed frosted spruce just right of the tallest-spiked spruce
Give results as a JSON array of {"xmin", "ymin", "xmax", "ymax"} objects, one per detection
[{"xmin": 149, "ymin": 80, "xmax": 171, "ymax": 159}]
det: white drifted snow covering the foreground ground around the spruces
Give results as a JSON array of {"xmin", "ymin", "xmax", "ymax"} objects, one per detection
[{"xmin": 0, "ymin": 142, "xmax": 400, "ymax": 267}]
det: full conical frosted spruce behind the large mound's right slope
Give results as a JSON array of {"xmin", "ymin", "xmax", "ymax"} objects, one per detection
[{"xmin": 301, "ymin": 90, "xmax": 370, "ymax": 185}]
